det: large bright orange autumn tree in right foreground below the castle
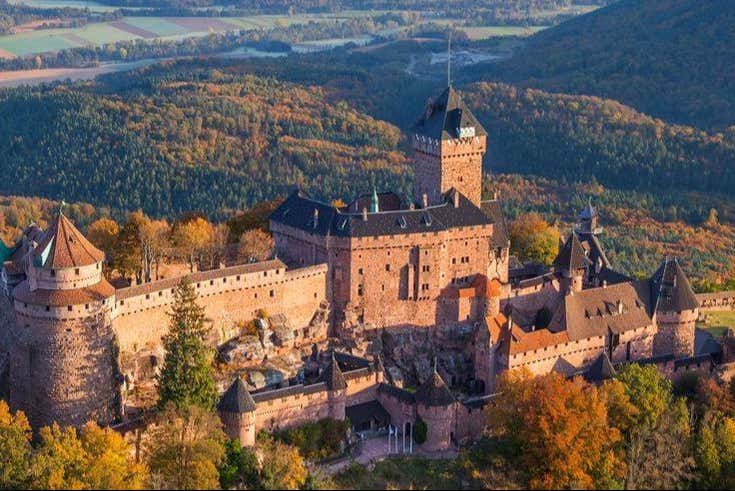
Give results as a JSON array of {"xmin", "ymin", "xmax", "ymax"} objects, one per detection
[{"xmin": 487, "ymin": 371, "xmax": 625, "ymax": 489}]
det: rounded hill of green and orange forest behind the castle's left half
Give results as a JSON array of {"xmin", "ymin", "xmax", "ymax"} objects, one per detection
[{"xmin": 0, "ymin": 63, "xmax": 406, "ymax": 216}]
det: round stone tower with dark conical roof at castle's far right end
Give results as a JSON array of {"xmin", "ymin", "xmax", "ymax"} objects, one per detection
[{"xmin": 651, "ymin": 256, "xmax": 699, "ymax": 358}]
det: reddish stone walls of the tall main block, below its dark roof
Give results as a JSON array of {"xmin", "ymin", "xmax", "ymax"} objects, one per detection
[{"xmin": 271, "ymin": 222, "xmax": 495, "ymax": 327}]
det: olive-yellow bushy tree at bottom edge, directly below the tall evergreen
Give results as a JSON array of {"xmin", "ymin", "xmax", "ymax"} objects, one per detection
[{"xmin": 144, "ymin": 404, "xmax": 226, "ymax": 489}]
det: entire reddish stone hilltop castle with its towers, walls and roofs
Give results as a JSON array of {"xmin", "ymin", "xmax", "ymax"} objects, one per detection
[{"xmin": 2, "ymin": 87, "xmax": 714, "ymax": 450}]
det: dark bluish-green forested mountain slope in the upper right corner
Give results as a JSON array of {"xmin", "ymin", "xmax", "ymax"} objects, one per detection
[{"xmin": 472, "ymin": 0, "xmax": 735, "ymax": 129}]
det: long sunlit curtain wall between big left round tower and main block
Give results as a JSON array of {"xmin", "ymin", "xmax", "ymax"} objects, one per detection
[{"xmin": 113, "ymin": 261, "xmax": 327, "ymax": 352}]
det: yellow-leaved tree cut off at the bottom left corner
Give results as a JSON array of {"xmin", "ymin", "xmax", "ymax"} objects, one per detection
[{"xmin": 0, "ymin": 400, "xmax": 31, "ymax": 489}]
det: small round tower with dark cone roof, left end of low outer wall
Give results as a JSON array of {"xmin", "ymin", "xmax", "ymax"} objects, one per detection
[{"xmin": 217, "ymin": 377, "xmax": 256, "ymax": 447}]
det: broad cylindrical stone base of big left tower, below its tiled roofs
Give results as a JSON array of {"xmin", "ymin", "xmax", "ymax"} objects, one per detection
[{"xmin": 10, "ymin": 307, "xmax": 120, "ymax": 428}]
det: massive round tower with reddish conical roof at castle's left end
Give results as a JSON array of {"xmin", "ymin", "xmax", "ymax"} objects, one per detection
[{"xmin": 10, "ymin": 212, "xmax": 120, "ymax": 428}]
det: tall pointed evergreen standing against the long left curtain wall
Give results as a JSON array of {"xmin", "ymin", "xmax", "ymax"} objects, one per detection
[{"xmin": 158, "ymin": 278, "xmax": 218, "ymax": 409}]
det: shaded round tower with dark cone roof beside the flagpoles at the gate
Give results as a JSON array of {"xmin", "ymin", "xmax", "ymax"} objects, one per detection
[{"xmin": 415, "ymin": 370, "xmax": 456, "ymax": 452}]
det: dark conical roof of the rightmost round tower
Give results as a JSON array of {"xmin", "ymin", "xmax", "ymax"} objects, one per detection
[{"xmin": 651, "ymin": 256, "xmax": 699, "ymax": 312}]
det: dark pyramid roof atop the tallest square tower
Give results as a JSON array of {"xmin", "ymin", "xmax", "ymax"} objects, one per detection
[{"xmin": 411, "ymin": 87, "xmax": 487, "ymax": 140}]
